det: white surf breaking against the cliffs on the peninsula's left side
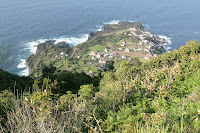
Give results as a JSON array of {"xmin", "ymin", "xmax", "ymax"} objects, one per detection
[{"xmin": 17, "ymin": 34, "xmax": 89, "ymax": 76}]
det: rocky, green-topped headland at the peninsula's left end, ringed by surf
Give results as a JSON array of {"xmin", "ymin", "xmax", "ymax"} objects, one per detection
[{"xmin": 26, "ymin": 40, "xmax": 72, "ymax": 76}]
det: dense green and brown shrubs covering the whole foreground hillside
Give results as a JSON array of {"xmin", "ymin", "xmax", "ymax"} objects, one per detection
[{"xmin": 0, "ymin": 41, "xmax": 200, "ymax": 133}]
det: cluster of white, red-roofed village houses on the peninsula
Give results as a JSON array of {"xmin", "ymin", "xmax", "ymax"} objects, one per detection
[{"xmin": 85, "ymin": 27, "xmax": 167, "ymax": 67}]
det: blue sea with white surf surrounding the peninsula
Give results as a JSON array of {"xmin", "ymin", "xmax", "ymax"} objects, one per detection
[{"xmin": 0, "ymin": 0, "xmax": 200, "ymax": 75}]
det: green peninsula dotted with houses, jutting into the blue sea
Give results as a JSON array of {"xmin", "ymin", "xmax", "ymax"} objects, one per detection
[{"xmin": 26, "ymin": 21, "xmax": 170, "ymax": 77}]
